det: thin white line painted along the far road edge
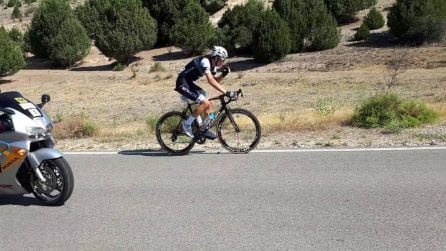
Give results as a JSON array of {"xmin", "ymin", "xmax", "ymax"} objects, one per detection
[{"xmin": 64, "ymin": 146, "xmax": 446, "ymax": 155}]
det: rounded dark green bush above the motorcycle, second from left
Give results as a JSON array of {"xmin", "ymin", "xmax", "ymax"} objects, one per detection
[{"xmin": 27, "ymin": 0, "xmax": 90, "ymax": 66}]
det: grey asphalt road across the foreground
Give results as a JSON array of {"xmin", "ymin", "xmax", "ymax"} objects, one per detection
[{"xmin": 0, "ymin": 149, "xmax": 446, "ymax": 250}]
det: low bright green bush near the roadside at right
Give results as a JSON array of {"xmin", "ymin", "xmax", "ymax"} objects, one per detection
[{"xmin": 352, "ymin": 94, "xmax": 438, "ymax": 131}]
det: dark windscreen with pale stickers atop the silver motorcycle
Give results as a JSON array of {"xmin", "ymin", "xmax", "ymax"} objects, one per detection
[{"xmin": 0, "ymin": 92, "xmax": 42, "ymax": 119}]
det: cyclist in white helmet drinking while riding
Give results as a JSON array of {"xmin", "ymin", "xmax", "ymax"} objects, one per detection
[{"xmin": 175, "ymin": 46, "xmax": 237, "ymax": 139}]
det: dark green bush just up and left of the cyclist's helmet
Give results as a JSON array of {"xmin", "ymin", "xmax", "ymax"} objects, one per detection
[{"xmin": 171, "ymin": 0, "xmax": 217, "ymax": 54}]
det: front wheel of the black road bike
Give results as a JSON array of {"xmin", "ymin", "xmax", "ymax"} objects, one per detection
[{"xmin": 217, "ymin": 108, "xmax": 261, "ymax": 153}]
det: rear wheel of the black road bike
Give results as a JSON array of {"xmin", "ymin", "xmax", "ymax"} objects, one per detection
[{"xmin": 156, "ymin": 111, "xmax": 195, "ymax": 155}]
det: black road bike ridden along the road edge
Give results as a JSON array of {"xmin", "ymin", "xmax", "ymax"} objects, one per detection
[{"xmin": 156, "ymin": 89, "xmax": 261, "ymax": 155}]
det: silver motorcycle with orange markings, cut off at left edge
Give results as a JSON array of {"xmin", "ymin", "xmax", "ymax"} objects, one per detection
[{"xmin": 0, "ymin": 92, "xmax": 74, "ymax": 206}]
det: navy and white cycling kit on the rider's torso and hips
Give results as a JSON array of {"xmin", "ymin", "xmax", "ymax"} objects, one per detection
[{"xmin": 175, "ymin": 57, "xmax": 216, "ymax": 103}]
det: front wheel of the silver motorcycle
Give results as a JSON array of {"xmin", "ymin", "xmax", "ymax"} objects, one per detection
[{"xmin": 30, "ymin": 158, "xmax": 74, "ymax": 206}]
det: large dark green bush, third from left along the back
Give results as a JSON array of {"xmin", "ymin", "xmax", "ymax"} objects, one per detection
[{"xmin": 76, "ymin": 0, "xmax": 156, "ymax": 64}]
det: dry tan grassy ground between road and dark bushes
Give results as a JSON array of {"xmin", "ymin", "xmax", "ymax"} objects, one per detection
[{"xmin": 0, "ymin": 0, "xmax": 446, "ymax": 151}]
